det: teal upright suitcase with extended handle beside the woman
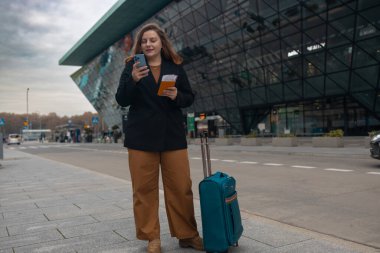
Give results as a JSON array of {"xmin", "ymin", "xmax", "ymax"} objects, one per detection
[{"xmin": 199, "ymin": 133, "xmax": 243, "ymax": 253}]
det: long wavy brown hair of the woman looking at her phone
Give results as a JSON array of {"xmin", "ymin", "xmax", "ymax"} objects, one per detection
[{"xmin": 127, "ymin": 23, "xmax": 183, "ymax": 64}]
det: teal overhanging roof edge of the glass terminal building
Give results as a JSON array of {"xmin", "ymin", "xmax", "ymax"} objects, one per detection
[{"xmin": 59, "ymin": 0, "xmax": 171, "ymax": 66}]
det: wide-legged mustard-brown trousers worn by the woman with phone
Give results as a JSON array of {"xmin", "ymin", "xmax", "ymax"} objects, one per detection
[{"xmin": 128, "ymin": 149, "xmax": 198, "ymax": 240}]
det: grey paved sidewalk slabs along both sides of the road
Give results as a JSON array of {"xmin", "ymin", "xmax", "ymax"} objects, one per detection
[{"xmin": 0, "ymin": 149, "xmax": 380, "ymax": 253}]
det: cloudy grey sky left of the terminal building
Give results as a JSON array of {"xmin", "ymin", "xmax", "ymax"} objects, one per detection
[{"xmin": 0, "ymin": 0, "xmax": 117, "ymax": 116}]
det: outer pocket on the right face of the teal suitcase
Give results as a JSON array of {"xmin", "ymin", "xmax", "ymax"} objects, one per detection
[{"xmin": 225, "ymin": 191, "xmax": 243, "ymax": 246}]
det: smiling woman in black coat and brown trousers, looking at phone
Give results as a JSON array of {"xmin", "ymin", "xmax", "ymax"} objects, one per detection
[{"xmin": 116, "ymin": 24, "xmax": 203, "ymax": 253}]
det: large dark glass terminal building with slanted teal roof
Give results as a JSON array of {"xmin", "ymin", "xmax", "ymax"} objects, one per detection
[{"xmin": 59, "ymin": 0, "xmax": 380, "ymax": 136}]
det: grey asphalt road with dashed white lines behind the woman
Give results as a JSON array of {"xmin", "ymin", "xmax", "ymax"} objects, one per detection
[{"xmin": 6, "ymin": 143, "xmax": 380, "ymax": 248}]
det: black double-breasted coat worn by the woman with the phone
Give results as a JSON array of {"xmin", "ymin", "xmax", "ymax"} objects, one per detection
[{"xmin": 116, "ymin": 59, "xmax": 194, "ymax": 152}]
